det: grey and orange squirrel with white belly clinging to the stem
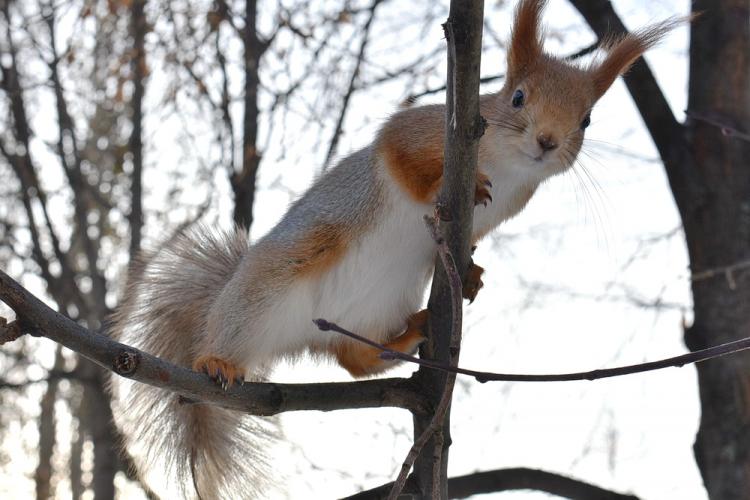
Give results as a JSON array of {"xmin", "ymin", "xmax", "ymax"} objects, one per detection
[{"xmin": 111, "ymin": 0, "xmax": 683, "ymax": 499}]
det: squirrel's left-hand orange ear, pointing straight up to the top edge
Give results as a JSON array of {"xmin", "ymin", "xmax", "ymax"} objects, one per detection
[{"xmin": 508, "ymin": 0, "xmax": 547, "ymax": 80}]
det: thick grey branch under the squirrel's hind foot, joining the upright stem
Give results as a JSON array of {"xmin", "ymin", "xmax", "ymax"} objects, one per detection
[{"xmin": 0, "ymin": 271, "xmax": 428, "ymax": 416}]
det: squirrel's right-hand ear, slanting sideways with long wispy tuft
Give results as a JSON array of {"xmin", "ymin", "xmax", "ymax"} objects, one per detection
[{"xmin": 590, "ymin": 16, "xmax": 696, "ymax": 99}]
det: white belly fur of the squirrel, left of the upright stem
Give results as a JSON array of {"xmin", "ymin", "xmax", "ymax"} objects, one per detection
[{"xmin": 253, "ymin": 162, "xmax": 435, "ymax": 359}]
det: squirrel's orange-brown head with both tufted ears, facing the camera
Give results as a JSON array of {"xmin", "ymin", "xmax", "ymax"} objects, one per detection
[{"xmin": 484, "ymin": 0, "xmax": 684, "ymax": 178}]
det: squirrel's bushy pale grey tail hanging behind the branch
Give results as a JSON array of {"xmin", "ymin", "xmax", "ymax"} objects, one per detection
[{"xmin": 111, "ymin": 227, "xmax": 278, "ymax": 500}]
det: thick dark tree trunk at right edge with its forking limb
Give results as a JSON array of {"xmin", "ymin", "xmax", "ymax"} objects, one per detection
[{"xmin": 571, "ymin": 0, "xmax": 750, "ymax": 500}]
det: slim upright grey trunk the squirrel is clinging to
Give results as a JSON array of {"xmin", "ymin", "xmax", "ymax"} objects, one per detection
[{"xmin": 413, "ymin": 0, "xmax": 484, "ymax": 499}]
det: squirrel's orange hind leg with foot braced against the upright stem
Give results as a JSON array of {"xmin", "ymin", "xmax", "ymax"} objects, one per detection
[{"xmin": 333, "ymin": 309, "xmax": 427, "ymax": 377}]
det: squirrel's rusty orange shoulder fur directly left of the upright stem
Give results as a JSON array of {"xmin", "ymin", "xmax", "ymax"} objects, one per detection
[{"xmin": 379, "ymin": 106, "xmax": 445, "ymax": 203}]
